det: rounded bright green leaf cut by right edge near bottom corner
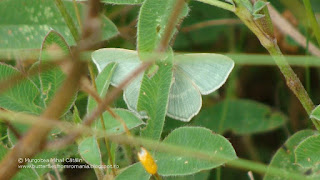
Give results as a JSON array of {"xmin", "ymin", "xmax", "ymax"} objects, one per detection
[{"xmin": 294, "ymin": 134, "xmax": 320, "ymax": 168}]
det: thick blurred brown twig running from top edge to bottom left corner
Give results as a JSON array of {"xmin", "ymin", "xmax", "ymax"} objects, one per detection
[{"xmin": 0, "ymin": 0, "xmax": 100, "ymax": 179}]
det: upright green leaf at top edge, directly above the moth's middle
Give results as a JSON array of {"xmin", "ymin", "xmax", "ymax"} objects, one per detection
[{"xmin": 137, "ymin": 0, "xmax": 189, "ymax": 60}]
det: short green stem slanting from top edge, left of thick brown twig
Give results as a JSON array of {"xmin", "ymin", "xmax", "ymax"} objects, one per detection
[{"xmin": 54, "ymin": 0, "xmax": 80, "ymax": 42}]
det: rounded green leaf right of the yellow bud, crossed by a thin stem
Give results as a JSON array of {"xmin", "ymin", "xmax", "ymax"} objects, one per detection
[{"xmin": 155, "ymin": 127, "xmax": 237, "ymax": 176}]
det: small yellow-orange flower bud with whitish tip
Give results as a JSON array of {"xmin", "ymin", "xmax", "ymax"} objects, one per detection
[{"xmin": 138, "ymin": 147, "xmax": 158, "ymax": 175}]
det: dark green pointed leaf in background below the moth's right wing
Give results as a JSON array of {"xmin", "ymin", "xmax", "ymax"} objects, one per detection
[{"xmin": 192, "ymin": 99, "xmax": 286, "ymax": 135}]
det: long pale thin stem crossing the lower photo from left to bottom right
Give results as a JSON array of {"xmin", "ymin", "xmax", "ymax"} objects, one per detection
[{"xmin": 0, "ymin": 110, "xmax": 306, "ymax": 179}]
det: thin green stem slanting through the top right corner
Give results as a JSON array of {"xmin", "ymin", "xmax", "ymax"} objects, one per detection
[{"xmin": 303, "ymin": 0, "xmax": 320, "ymax": 46}]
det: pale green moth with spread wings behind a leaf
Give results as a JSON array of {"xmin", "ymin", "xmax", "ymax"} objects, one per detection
[{"xmin": 92, "ymin": 48, "xmax": 234, "ymax": 121}]
